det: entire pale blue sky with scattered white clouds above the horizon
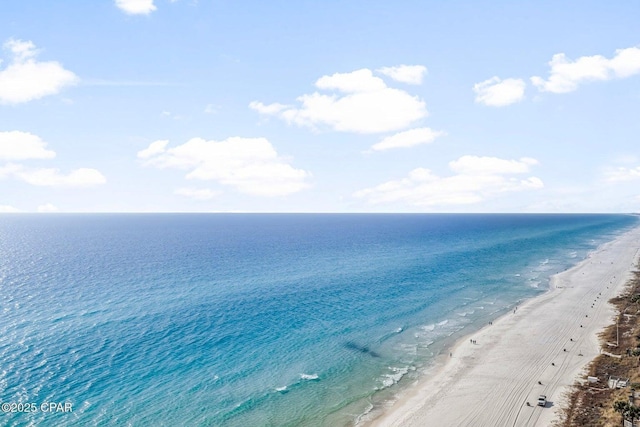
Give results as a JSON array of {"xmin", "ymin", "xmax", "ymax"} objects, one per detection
[{"xmin": 0, "ymin": 0, "xmax": 640, "ymax": 213}]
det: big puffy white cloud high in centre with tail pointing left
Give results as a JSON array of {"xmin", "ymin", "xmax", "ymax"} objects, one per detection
[{"xmin": 249, "ymin": 68, "xmax": 428, "ymax": 133}]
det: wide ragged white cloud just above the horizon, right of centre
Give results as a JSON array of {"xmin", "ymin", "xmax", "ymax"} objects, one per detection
[{"xmin": 354, "ymin": 156, "xmax": 544, "ymax": 207}]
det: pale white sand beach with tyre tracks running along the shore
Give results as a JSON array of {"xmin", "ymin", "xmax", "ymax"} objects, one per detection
[{"xmin": 372, "ymin": 228, "xmax": 640, "ymax": 427}]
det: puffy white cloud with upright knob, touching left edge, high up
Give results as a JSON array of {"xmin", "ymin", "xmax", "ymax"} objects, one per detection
[{"xmin": 0, "ymin": 39, "xmax": 78, "ymax": 104}]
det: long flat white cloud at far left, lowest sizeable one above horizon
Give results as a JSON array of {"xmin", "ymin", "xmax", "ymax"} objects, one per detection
[{"xmin": 14, "ymin": 167, "xmax": 107, "ymax": 188}]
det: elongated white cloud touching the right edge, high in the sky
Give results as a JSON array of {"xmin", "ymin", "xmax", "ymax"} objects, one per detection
[{"xmin": 531, "ymin": 47, "xmax": 640, "ymax": 93}]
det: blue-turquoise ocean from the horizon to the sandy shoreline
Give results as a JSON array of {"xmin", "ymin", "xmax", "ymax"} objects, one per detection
[{"xmin": 0, "ymin": 214, "xmax": 640, "ymax": 427}]
